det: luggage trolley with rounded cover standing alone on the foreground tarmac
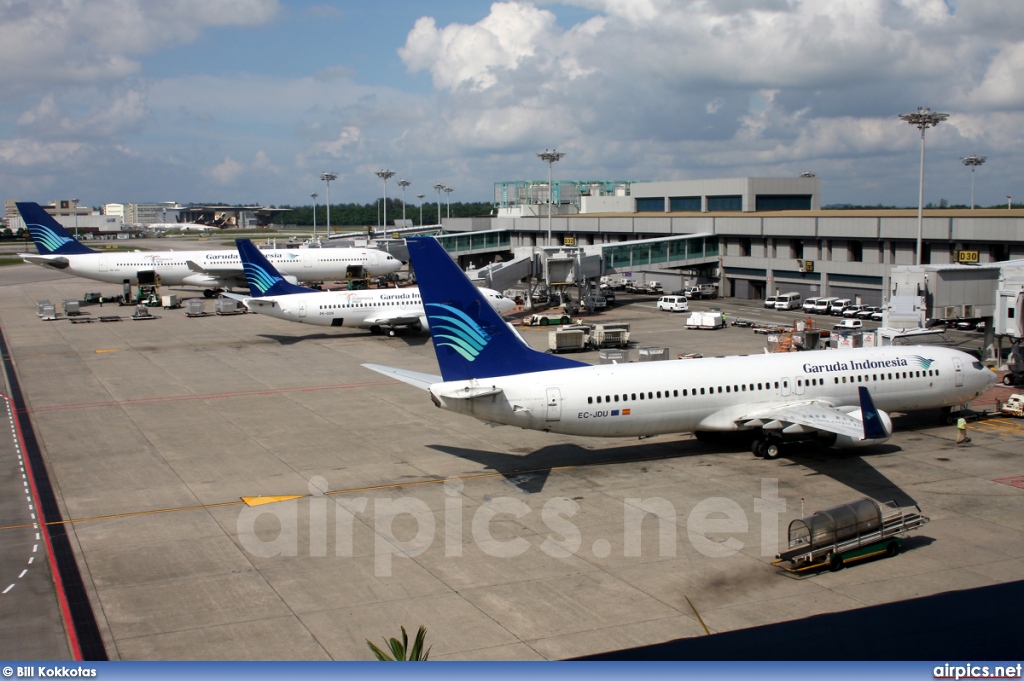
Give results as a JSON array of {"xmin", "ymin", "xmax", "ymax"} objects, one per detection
[{"xmin": 772, "ymin": 498, "xmax": 929, "ymax": 574}]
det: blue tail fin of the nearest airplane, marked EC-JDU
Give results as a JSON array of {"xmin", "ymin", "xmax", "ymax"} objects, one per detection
[{"xmin": 406, "ymin": 237, "xmax": 589, "ymax": 381}]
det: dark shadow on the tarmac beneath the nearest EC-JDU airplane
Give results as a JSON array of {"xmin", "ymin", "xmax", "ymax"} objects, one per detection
[{"xmin": 428, "ymin": 440, "xmax": 916, "ymax": 506}]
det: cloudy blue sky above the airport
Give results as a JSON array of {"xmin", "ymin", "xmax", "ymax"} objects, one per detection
[{"xmin": 0, "ymin": 0, "xmax": 1024, "ymax": 206}]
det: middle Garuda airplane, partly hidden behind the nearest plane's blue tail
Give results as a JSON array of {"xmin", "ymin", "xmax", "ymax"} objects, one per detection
[{"xmin": 234, "ymin": 239, "xmax": 515, "ymax": 336}]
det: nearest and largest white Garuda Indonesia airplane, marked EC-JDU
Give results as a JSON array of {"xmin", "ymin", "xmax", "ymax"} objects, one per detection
[{"xmin": 364, "ymin": 238, "xmax": 995, "ymax": 458}]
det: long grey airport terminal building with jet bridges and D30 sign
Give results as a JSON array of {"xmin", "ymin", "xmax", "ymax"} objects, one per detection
[{"xmin": 443, "ymin": 174, "xmax": 1024, "ymax": 305}]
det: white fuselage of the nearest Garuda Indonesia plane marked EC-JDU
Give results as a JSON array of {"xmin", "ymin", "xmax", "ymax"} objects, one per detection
[{"xmin": 430, "ymin": 347, "xmax": 993, "ymax": 437}]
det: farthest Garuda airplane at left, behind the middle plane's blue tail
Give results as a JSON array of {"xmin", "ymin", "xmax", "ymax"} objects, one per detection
[{"xmin": 17, "ymin": 203, "xmax": 401, "ymax": 296}]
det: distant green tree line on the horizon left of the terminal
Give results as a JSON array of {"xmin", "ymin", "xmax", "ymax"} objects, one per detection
[{"xmin": 274, "ymin": 199, "xmax": 494, "ymax": 228}]
